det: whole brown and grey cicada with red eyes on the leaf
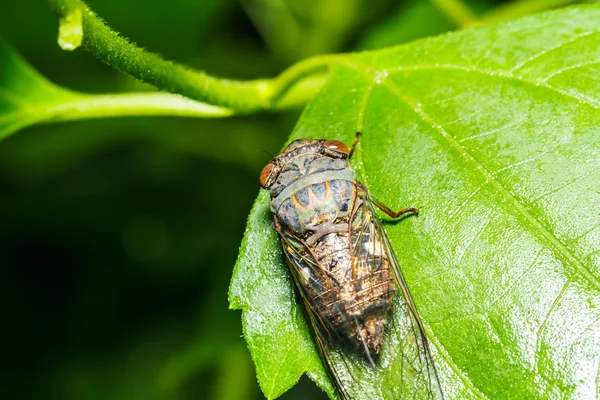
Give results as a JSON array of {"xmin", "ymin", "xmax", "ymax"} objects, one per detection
[{"xmin": 260, "ymin": 134, "xmax": 443, "ymax": 400}]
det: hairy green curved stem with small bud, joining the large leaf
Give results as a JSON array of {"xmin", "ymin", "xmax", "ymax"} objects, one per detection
[{"xmin": 50, "ymin": 0, "xmax": 334, "ymax": 114}]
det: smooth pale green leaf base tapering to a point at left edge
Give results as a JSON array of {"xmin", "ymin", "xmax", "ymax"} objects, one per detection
[{"xmin": 0, "ymin": 39, "xmax": 232, "ymax": 139}]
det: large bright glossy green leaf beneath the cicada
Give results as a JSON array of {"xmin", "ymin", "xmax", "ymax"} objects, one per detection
[{"xmin": 230, "ymin": 6, "xmax": 600, "ymax": 399}]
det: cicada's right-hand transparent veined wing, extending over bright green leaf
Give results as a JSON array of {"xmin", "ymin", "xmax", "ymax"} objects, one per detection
[{"xmin": 350, "ymin": 184, "xmax": 444, "ymax": 400}]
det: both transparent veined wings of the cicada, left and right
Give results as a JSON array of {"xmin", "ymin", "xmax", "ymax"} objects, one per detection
[{"xmin": 278, "ymin": 184, "xmax": 443, "ymax": 400}]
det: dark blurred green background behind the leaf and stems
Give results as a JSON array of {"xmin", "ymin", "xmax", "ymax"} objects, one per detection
[{"xmin": 0, "ymin": 0, "xmax": 572, "ymax": 400}]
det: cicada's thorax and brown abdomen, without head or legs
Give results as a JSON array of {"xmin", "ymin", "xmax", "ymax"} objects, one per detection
[{"xmin": 270, "ymin": 143, "xmax": 395, "ymax": 361}]
